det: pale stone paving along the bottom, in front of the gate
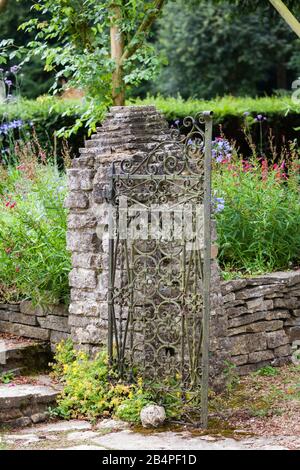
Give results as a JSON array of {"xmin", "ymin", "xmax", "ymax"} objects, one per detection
[{"xmin": 0, "ymin": 420, "xmax": 300, "ymax": 451}]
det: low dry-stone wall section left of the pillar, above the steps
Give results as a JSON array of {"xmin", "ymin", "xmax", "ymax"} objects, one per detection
[{"xmin": 0, "ymin": 301, "xmax": 70, "ymax": 347}]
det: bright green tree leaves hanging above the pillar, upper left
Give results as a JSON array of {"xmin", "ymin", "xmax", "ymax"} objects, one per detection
[{"xmin": 1, "ymin": 0, "xmax": 164, "ymax": 130}]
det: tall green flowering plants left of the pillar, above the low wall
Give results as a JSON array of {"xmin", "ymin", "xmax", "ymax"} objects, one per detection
[{"xmin": 0, "ymin": 138, "xmax": 70, "ymax": 304}]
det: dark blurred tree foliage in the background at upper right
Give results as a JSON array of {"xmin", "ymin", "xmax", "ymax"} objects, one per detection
[{"xmin": 141, "ymin": 0, "xmax": 300, "ymax": 99}]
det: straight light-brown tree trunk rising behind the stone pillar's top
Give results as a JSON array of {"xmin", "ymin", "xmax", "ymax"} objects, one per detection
[{"xmin": 110, "ymin": 18, "xmax": 125, "ymax": 106}]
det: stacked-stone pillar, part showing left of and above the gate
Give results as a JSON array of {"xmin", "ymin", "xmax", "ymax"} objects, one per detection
[{"xmin": 65, "ymin": 106, "xmax": 169, "ymax": 353}]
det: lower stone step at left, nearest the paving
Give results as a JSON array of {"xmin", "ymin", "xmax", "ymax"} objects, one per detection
[{"xmin": 0, "ymin": 377, "xmax": 60, "ymax": 428}]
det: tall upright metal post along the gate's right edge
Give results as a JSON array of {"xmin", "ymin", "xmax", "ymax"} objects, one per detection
[{"xmin": 201, "ymin": 112, "xmax": 213, "ymax": 429}]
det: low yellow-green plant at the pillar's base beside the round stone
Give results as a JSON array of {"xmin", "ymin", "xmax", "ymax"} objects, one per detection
[{"xmin": 53, "ymin": 341, "xmax": 153, "ymax": 423}]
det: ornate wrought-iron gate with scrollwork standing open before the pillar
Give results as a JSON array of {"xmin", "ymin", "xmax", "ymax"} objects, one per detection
[{"xmin": 108, "ymin": 112, "xmax": 212, "ymax": 427}]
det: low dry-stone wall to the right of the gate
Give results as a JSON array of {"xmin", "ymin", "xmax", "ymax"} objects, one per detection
[{"xmin": 221, "ymin": 271, "xmax": 300, "ymax": 374}]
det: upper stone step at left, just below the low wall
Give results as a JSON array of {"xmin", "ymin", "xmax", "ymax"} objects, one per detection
[{"xmin": 0, "ymin": 336, "xmax": 52, "ymax": 376}]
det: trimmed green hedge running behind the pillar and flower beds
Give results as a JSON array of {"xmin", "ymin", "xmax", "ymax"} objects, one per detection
[{"xmin": 0, "ymin": 96, "xmax": 300, "ymax": 153}]
